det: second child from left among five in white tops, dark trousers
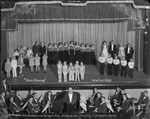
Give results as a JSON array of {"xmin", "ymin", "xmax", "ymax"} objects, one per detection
[{"xmin": 107, "ymin": 54, "xmax": 113, "ymax": 75}]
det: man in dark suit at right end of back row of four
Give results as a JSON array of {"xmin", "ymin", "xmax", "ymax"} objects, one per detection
[{"xmin": 125, "ymin": 43, "xmax": 134, "ymax": 62}]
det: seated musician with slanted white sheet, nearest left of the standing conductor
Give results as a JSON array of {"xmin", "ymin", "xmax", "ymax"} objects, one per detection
[{"xmin": 42, "ymin": 91, "xmax": 52, "ymax": 113}]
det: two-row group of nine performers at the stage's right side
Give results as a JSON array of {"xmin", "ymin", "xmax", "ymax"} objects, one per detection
[{"xmin": 98, "ymin": 40, "xmax": 134, "ymax": 78}]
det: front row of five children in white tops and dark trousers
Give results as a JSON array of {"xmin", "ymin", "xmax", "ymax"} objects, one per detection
[{"xmin": 98, "ymin": 53, "xmax": 134, "ymax": 78}]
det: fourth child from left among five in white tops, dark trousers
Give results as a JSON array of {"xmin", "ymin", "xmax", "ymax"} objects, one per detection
[{"xmin": 121, "ymin": 57, "xmax": 127, "ymax": 77}]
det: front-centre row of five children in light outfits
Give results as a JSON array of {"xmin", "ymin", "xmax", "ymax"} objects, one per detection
[{"xmin": 57, "ymin": 61, "xmax": 85, "ymax": 82}]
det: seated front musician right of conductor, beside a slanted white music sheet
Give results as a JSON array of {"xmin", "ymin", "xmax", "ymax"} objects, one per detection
[{"xmin": 94, "ymin": 96, "xmax": 107, "ymax": 113}]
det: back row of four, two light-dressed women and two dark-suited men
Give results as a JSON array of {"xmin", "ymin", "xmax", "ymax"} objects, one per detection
[{"xmin": 100, "ymin": 40, "xmax": 134, "ymax": 62}]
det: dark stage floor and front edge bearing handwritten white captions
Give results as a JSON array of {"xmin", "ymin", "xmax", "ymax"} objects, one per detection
[{"xmin": 8, "ymin": 65, "xmax": 150, "ymax": 90}]
